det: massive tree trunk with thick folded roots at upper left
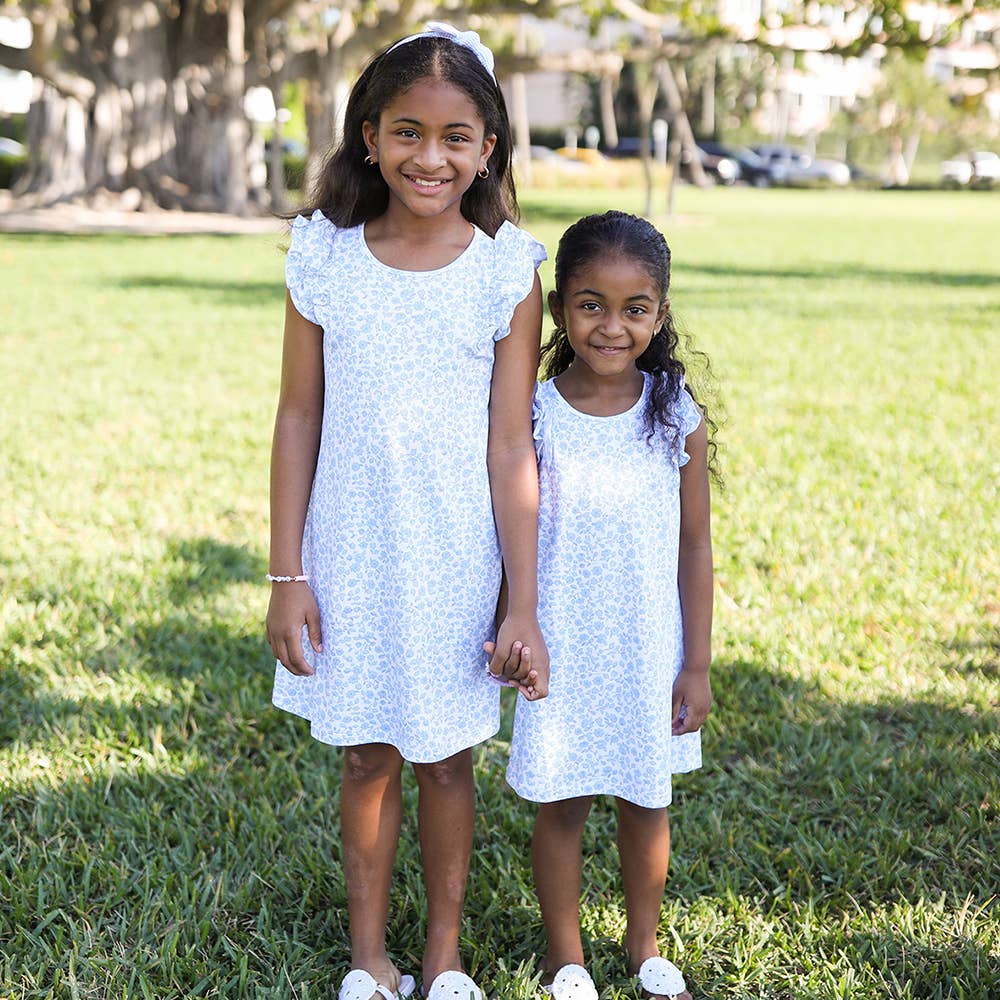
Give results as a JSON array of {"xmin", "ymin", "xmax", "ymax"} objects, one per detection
[{"xmin": 0, "ymin": 0, "xmax": 294, "ymax": 212}]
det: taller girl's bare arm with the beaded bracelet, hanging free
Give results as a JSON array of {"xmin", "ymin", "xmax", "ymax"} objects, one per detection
[{"xmin": 267, "ymin": 293, "xmax": 323, "ymax": 675}]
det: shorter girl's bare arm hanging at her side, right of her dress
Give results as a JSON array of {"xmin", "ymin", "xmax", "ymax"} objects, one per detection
[{"xmin": 673, "ymin": 420, "xmax": 712, "ymax": 735}]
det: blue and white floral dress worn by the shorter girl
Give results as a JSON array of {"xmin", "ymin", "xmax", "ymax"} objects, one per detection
[{"xmin": 507, "ymin": 376, "xmax": 701, "ymax": 808}]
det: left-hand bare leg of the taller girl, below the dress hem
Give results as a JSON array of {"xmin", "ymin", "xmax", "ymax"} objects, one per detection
[{"xmin": 340, "ymin": 743, "xmax": 403, "ymax": 1000}]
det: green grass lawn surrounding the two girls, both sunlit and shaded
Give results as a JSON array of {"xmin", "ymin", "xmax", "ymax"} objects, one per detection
[{"xmin": 0, "ymin": 188, "xmax": 1000, "ymax": 1000}]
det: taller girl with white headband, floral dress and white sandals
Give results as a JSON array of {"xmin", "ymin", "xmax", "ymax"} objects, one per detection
[{"xmin": 267, "ymin": 24, "xmax": 547, "ymax": 1000}]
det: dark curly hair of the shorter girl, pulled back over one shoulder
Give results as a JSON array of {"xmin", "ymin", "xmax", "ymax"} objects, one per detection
[{"xmin": 541, "ymin": 211, "xmax": 720, "ymax": 481}]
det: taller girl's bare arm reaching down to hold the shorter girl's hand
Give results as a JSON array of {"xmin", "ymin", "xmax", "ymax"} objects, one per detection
[{"xmin": 487, "ymin": 275, "xmax": 549, "ymax": 697}]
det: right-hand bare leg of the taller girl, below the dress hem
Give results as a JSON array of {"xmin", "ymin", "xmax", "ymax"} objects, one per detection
[{"xmin": 413, "ymin": 750, "xmax": 475, "ymax": 987}]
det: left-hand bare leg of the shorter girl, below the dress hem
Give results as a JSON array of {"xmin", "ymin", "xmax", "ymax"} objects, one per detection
[{"xmin": 531, "ymin": 795, "xmax": 594, "ymax": 982}]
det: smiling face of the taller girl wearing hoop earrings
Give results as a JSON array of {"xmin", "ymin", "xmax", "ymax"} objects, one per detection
[{"xmin": 362, "ymin": 78, "xmax": 496, "ymax": 227}]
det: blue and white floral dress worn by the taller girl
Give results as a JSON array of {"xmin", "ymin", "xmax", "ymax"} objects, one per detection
[{"xmin": 273, "ymin": 212, "xmax": 545, "ymax": 762}]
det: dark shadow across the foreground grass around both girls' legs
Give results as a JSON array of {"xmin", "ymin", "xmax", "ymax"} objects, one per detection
[{"xmin": 0, "ymin": 584, "xmax": 1000, "ymax": 998}]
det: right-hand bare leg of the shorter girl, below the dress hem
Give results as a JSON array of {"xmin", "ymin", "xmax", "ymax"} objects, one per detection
[{"xmin": 618, "ymin": 799, "xmax": 691, "ymax": 1000}]
